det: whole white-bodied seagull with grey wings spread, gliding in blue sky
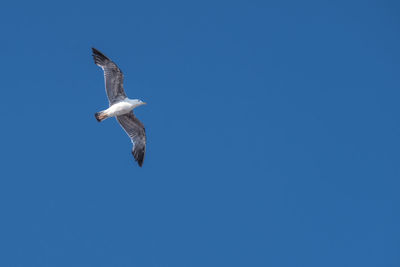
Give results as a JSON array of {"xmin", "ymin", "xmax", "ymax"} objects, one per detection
[{"xmin": 92, "ymin": 48, "xmax": 146, "ymax": 167}]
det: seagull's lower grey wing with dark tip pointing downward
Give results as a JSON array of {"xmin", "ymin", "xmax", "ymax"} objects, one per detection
[{"xmin": 117, "ymin": 112, "xmax": 146, "ymax": 167}]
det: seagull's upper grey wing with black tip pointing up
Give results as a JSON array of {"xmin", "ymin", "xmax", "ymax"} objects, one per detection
[{"xmin": 92, "ymin": 48, "xmax": 126, "ymax": 106}]
